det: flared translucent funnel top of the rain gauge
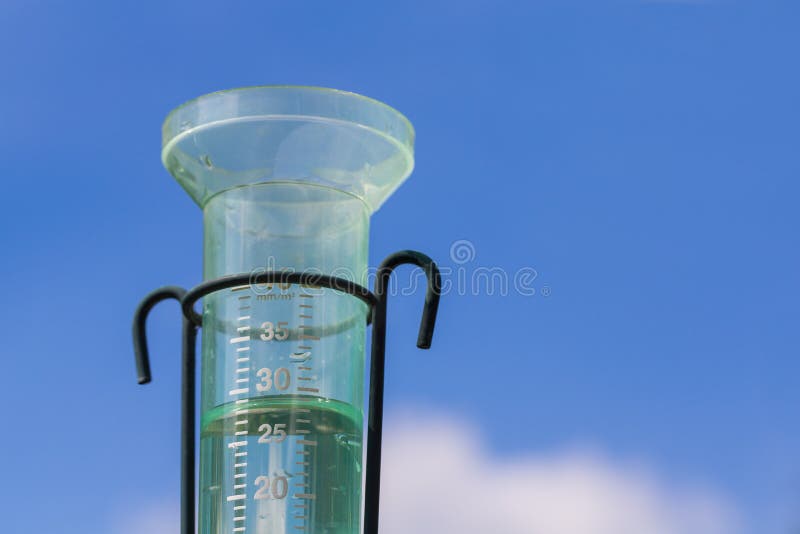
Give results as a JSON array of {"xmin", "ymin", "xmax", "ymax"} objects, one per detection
[{"xmin": 161, "ymin": 85, "xmax": 414, "ymax": 212}]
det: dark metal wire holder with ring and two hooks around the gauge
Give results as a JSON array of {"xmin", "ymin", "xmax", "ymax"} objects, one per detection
[{"xmin": 133, "ymin": 250, "xmax": 441, "ymax": 534}]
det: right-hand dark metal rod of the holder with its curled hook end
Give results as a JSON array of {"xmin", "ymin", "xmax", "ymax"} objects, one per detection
[{"xmin": 364, "ymin": 250, "xmax": 442, "ymax": 534}]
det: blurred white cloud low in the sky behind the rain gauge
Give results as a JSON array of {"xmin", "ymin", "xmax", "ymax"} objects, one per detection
[{"xmin": 112, "ymin": 410, "xmax": 741, "ymax": 534}]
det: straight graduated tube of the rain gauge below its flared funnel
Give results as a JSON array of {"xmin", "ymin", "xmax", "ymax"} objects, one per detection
[{"xmin": 200, "ymin": 183, "xmax": 369, "ymax": 533}]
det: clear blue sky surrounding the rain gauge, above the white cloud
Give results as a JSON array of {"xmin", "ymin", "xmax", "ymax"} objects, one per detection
[{"xmin": 0, "ymin": 0, "xmax": 800, "ymax": 534}]
